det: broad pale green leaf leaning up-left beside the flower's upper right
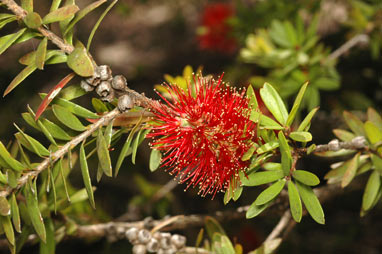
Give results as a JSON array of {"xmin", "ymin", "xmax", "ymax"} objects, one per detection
[{"xmin": 260, "ymin": 83, "xmax": 288, "ymax": 125}]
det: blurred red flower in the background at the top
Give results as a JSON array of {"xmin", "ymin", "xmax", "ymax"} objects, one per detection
[{"xmin": 198, "ymin": 3, "xmax": 236, "ymax": 53}]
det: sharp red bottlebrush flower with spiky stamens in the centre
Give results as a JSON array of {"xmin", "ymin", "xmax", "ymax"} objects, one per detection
[{"xmin": 148, "ymin": 74, "xmax": 256, "ymax": 196}]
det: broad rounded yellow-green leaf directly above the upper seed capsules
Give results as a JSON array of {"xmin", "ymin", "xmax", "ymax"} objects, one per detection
[{"xmin": 67, "ymin": 47, "xmax": 94, "ymax": 77}]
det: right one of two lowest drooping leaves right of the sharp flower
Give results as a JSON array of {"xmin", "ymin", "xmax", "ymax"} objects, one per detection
[{"xmin": 296, "ymin": 182, "xmax": 325, "ymax": 224}]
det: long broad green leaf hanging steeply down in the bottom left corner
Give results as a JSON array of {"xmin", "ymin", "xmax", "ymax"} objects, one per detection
[{"xmin": 25, "ymin": 182, "xmax": 46, "ymax": 242}]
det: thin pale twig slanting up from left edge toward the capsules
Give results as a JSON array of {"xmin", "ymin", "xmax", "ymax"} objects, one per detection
[{"xmin": 0, "ymin": 108, "xmax": 120, "ymax": 197}]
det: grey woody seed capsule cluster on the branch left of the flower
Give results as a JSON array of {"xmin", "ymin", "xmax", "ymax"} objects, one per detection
[{"xmin": 81, "ymin": 65, "xmax": 134, "ymax": 111}]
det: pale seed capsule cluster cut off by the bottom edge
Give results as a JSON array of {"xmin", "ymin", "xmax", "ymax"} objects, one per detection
[{"xmin": 126, "ymin": 228, "xmax": 186, "ymax": 254}]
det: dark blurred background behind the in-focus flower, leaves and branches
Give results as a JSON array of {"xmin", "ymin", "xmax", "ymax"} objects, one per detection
[{"xmin": 0, "ymin": 0, "xmax": 382, "ymax": 253}]
